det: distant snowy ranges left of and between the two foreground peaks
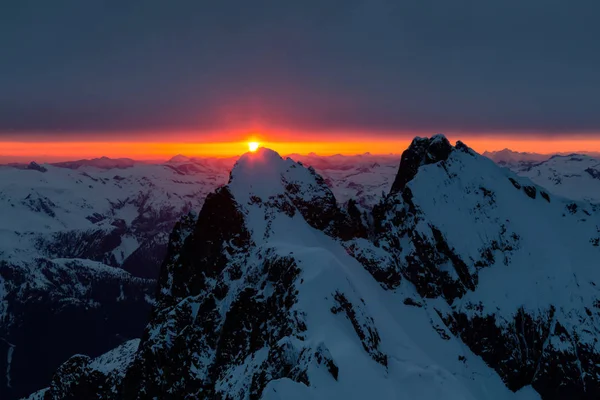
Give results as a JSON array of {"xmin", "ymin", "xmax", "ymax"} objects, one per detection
[{"xmin": 0, "ymin": 154, "xmax": 397, "ymax": 400}]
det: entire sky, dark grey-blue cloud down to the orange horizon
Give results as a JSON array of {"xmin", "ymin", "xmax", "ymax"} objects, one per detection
[{"xmin": 0, "ymin": 0, "xmax": 600, "ymax": 157}]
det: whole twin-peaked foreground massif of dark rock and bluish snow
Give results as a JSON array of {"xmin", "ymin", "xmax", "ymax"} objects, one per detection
[{"xmin": 32, "ymin": 136, "xmax": 600, "ymax": 400}]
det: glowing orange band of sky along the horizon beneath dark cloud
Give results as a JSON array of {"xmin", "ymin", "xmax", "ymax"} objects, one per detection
[{"xmin": 0, "ymin": 134, "xmax": 600, "ymax": 162}]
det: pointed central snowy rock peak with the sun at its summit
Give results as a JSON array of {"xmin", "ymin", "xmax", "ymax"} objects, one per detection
[{"xmin": 32, "ymin": 149, "xmax": 552, "ymax": 399}]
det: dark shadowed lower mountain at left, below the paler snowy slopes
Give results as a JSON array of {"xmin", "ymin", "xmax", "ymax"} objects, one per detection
[{"xmin": 0, "ymin": 258, "xmax": 155, "ymax": 399}]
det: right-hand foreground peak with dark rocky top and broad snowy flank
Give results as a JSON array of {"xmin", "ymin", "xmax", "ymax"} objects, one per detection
[{"xmin": 375, "ymin": 136, "xmax": 600, "ymax": 399}]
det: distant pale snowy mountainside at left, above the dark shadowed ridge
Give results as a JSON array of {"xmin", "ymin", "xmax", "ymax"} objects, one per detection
[{"xmin": 0, "ymin": 159, "xmax": 227, "ymax": 277}]
